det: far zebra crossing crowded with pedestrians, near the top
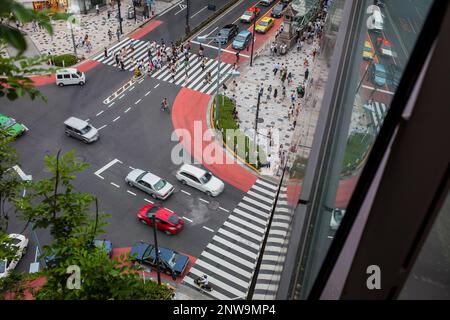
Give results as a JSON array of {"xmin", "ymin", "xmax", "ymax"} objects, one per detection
[{"xmin": 94, "ymin": 38, "xmax": 233, "ymax": 94}]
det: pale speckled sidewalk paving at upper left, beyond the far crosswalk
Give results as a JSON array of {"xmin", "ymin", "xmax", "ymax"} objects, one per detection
[{"xmin": 18, "ymin": 0, "xmax": 179, "ymax": 58}]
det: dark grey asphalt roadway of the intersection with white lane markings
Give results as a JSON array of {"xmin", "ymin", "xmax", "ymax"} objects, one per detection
[{"xmin": 0, "ymin": 0, "xmax": 266, "ymax": 271}]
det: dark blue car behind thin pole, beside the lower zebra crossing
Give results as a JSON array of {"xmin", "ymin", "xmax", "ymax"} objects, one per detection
[{"xmin": 130, "ymin": 241, "xmax": 189, "ymax": 277}]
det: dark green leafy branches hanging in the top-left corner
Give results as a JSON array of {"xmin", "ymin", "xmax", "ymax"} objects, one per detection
[{"xmin": 0, "ymin": 0, "xmax": 68, "ymax": 100}]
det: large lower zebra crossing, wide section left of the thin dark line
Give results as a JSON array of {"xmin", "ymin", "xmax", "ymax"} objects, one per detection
[{"xmin": 183, "ymin": 179, "xmax": 285, "ymax": 300}]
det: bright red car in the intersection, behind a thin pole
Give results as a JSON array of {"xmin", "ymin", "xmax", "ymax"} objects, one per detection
[{"xmin": 137, "ymin": 204, "xmax": 184, "ymax": 234}]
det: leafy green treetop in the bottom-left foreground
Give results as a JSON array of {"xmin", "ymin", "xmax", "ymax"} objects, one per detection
[{"xmin": 12, "ymin": 151, "xmax": 171, "ymax": 300}]
